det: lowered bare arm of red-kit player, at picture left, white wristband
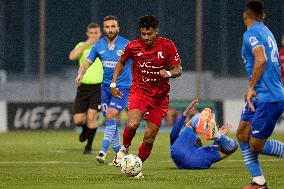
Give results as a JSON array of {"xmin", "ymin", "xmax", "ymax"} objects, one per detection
[{"xmin": 110, "ymin": 58, "xmax": 125, "ymax": 98}]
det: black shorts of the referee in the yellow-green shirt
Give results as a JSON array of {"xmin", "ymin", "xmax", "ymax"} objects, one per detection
[{"xmin": 74, "ymin": 83, "xmax": 101, "ymax": 114}]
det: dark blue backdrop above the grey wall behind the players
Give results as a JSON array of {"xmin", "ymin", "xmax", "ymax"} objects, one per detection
[{"xmin": 0, "ymin": 0, "xmax": 284, "ymax": 79}]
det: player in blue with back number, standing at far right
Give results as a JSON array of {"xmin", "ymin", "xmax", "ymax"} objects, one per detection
[{"xmin": 237, "ymin": 0, "xmax": 284, "ymax": 189}]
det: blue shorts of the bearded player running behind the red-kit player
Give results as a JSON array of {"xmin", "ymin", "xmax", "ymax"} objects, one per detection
[{"xmin": 101, "ymin": 84, "xmax": 130, "ymax": 116}]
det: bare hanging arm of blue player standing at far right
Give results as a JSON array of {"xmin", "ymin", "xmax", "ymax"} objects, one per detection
[{"xmin": 245, "ymin": 46, "xmax": 266, "ymax": 112}]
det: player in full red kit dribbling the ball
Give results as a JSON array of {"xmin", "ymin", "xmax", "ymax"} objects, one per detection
[{"xmin": 110, "ymin": 15, "xmax": 182, "ymax": 176}]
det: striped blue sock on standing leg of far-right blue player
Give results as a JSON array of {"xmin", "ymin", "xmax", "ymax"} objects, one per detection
[{"xmin": 239, "ymin": 142, "xmax": 262, "ymax": 177}]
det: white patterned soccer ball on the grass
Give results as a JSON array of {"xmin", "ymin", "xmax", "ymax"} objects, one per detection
[{"xmin": 120, "ymin": 154, "xmax": 142, "ymax": 177}]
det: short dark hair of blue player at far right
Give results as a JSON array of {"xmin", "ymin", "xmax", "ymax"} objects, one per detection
[{"xmin": 245, "ymin": 0, "xmax": 264, "ymax": 20}]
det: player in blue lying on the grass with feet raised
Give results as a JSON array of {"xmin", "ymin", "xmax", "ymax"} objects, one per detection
[{"xmin": 170, "ymin": 100, "xmax": 238, "ymax": 169}]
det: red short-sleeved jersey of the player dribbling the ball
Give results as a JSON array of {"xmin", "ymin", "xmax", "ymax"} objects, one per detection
[{"xmin": 121, "ymin": 37, "xmax": 181, "ymax": 98}]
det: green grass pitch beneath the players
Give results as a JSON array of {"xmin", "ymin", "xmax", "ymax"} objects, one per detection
[{"xmin": 0, "ymin": 131, "xmax": 284, "ymax": 189}]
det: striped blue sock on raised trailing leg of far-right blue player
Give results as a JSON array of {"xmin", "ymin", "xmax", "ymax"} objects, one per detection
[{"xmin": 261, "ymin": 140, "xmax": 284, "ymax": 157}]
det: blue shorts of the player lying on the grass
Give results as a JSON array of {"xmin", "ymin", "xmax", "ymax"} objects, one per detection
[{"xmin": 171, "ymin": 128, "xmax": 221, "ymax": 169}]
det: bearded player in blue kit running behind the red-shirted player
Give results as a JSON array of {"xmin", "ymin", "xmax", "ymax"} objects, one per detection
[{"xmin": 76, "ymin": 16, "xmax": 132, "ymax": 163}]
